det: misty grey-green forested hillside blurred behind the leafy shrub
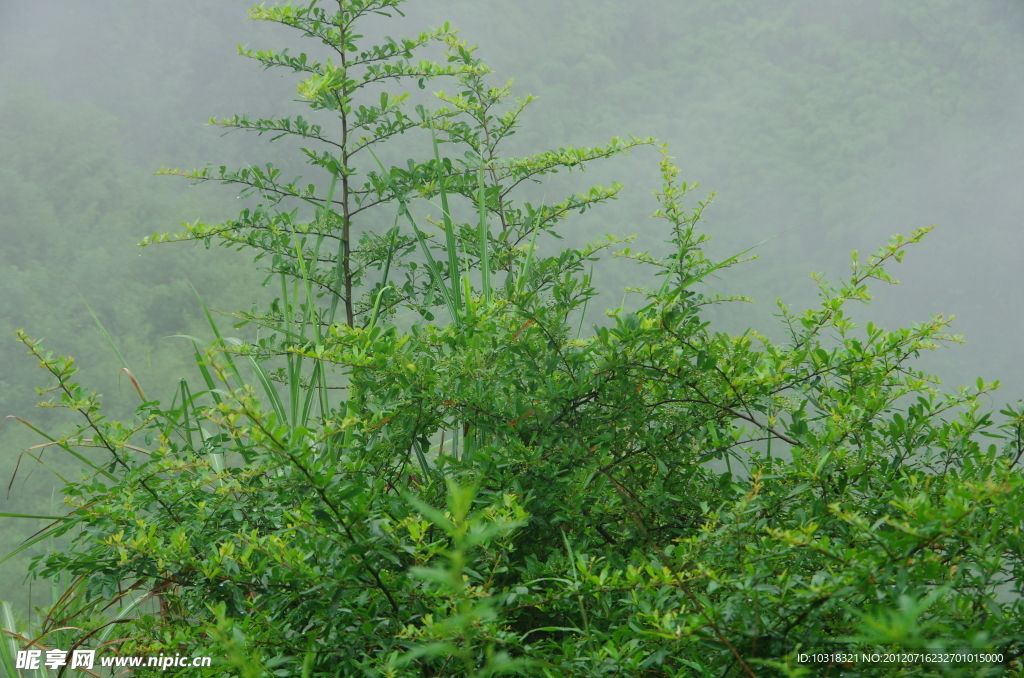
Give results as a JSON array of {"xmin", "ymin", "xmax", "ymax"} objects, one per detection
[{"xmin": 0, "ymin": 0, "xmax": 1024, "ymax": 618}]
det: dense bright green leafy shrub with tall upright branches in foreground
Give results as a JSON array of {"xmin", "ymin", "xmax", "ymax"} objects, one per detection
[{"xmin": 3, "ymin": 0, "xmax": 1024, "ymax": 677}]
